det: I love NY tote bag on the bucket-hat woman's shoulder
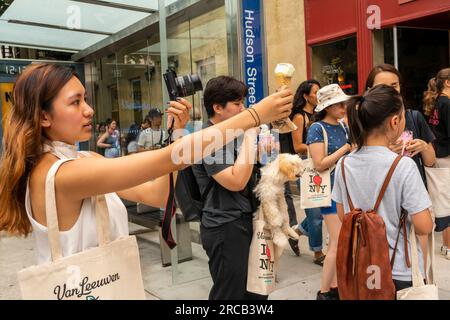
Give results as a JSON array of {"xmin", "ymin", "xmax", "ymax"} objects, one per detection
[{"xmin": 300, "ymin": 123, "xmax": 334, "ymax": 209}]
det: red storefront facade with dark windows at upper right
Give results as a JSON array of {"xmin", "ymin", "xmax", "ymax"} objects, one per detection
[{"xmin": 305, "ymin": 0, "xmax": 450, "ymax": 107}]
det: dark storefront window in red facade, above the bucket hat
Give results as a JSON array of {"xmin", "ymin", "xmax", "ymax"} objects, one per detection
[{"xmin": 312, "ymin": 37, "xmax": 358, "ymax": 95}]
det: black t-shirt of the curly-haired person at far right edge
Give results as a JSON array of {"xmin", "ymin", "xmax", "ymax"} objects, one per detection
[{"xmin": 429, "ymin": 96, "xmax": 450, "ymax": 158}]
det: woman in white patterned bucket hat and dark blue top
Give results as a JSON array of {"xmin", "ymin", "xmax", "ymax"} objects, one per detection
[{"xmin": 306, "ymin": 84, "xmax": 351, "ymax": 300}]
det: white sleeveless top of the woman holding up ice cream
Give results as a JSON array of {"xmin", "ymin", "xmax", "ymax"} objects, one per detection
[{"xmin": 25, "ymin": 142, "xmax": 129, "ymax": 264}]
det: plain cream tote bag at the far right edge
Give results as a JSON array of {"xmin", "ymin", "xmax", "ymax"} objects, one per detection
[{"xmin": 425, "ymin": 167, "xmax": 450, "ymax": 218}]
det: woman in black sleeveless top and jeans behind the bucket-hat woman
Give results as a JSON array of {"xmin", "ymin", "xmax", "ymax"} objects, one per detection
[{"xmin": 280, "ymin": 80, "xmax": 325, "ymax": 266}]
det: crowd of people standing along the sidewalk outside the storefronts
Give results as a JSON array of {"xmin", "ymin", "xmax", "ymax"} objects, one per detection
[{"xmin": 0, "ymin": 64, "xmax": 450, "ymax": 300}]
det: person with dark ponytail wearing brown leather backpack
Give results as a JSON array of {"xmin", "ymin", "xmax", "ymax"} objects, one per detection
[{"xmin": 332, "ymin": 85, "xmax": 433, "ymax": 299}]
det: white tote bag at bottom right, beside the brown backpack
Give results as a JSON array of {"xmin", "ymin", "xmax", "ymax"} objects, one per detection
[{"xmin": 397, "ymin": 225, "xmax": 439, "ymax": 300}]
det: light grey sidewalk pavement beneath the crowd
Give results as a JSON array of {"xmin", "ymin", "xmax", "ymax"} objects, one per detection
[{"xmin": 0, "ymin": 201, "xmax": 450, "ymax": 300}]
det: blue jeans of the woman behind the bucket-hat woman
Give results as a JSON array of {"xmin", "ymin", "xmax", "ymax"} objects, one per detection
[{"xmin": 297, "ymin": 180, "xmax": 323, "ymax": 252}]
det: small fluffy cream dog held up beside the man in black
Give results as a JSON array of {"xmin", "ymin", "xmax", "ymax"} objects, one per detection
[{"xmin": 255, "ymin": 154, "xmax": 304, "ymax": 248}]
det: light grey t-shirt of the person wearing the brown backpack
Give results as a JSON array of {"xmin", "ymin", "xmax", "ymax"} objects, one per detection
[{"xmin": 332, "ymin": 147, "xmax": 431, "ymax": 281}]
